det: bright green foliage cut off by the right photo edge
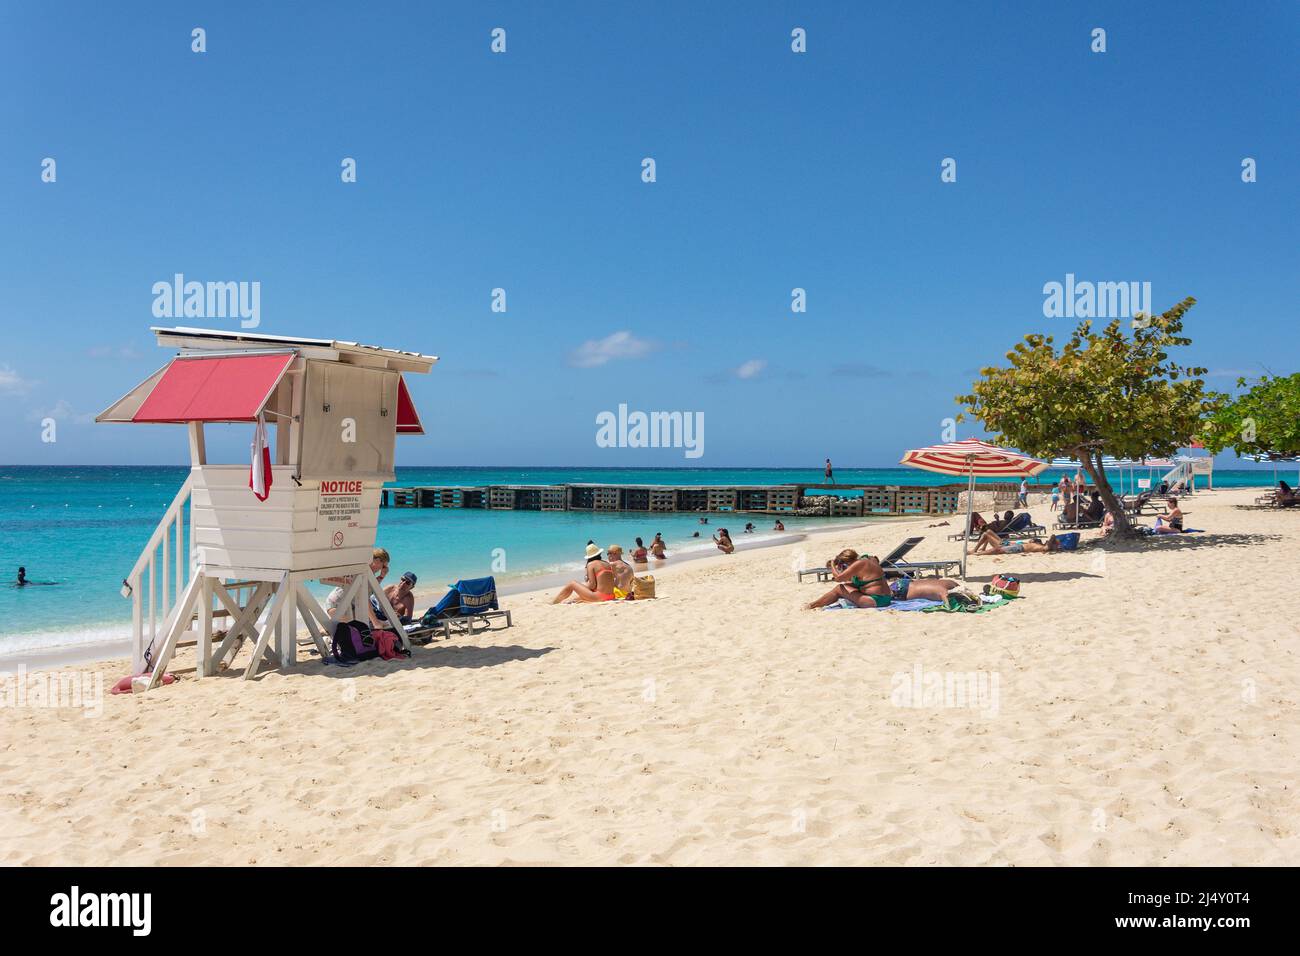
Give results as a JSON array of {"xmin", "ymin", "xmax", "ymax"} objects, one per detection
[{"xmin": 1201, "ymin": 372, "xmax": 1300, "ymax": 460}]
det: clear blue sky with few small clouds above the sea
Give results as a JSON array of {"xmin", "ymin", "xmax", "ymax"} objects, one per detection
[{"xmin": 0, "ymin": 1, "xmax": 1300, "ymax": 467}]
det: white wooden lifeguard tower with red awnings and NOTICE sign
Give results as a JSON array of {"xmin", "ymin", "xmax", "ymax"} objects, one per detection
[{"xmin": 95, "ymin": 328, "xmax": 438, "ymax": 688}]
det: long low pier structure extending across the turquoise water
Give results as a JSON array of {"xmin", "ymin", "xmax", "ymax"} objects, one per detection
[{"xmin": 381, "ymin": 483, "xmax": 966, "ymax": 518}]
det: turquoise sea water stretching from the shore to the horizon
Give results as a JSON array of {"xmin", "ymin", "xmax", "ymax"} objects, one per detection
[{"xmin": 0, "ymin": 466, "xmax": 1273, "ymax": 654}]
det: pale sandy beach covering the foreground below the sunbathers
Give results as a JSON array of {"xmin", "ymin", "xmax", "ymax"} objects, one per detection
[{"xmin": 0, "ymin": 490, "xmax": 1300, "ymax": 865}]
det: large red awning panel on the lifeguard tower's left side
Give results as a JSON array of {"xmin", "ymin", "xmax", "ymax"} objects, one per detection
[{"xmin": 131, "ymin": 352, "xmax": 294, "ymax": 421}]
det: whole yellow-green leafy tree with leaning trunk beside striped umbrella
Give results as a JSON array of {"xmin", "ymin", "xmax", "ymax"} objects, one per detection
[{"xmin": 957, "ymin": 298, "xmax": 1221, "ymax": 533}]
